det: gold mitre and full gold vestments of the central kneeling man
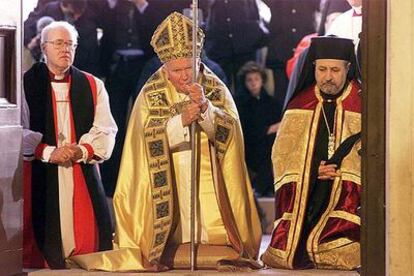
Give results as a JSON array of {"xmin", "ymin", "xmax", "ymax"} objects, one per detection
[{"xmin": 72, "ymin": 13, "xmax": 261, "ymax": 271}]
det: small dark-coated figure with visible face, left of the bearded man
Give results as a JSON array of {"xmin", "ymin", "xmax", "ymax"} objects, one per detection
[{"xmin": 236, "ymin": 61, "xmax": 282, "ymax": 197}]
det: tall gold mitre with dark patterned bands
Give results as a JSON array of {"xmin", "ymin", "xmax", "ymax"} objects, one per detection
[{"xmin": 151, "ymin": 12, "xmax": 204, "ymax": 63}]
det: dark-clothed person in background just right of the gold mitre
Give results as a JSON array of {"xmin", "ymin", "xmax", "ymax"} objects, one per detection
[{"xmin": 200, "ymin": 0, "xmax": 269, "ymax": 94}]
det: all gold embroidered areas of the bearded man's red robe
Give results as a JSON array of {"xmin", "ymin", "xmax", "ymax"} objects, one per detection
[{"xmin": 262, "ymin": 83, "xmax": 360, "ymax": 269}]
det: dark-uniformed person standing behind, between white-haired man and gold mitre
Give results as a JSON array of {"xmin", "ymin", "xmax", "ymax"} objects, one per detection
[{"xmin": 101, "ymin": 0, "xmax": 190, "ymax": 197}]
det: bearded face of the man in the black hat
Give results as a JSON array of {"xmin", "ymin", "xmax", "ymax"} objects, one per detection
[{"xmin": 315, "ymin": 59, "xmax": 349, "ymax": 95}]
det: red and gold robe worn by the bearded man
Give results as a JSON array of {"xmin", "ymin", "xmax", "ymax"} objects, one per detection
[{"xmin": 262, "ymin": 82, "xmax": 361, "ymax": 269}]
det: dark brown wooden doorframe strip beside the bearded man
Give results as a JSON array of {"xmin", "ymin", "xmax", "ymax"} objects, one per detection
[{"xmin": 361, "ymin": 0, "xmax": 387, "ymax": 276}]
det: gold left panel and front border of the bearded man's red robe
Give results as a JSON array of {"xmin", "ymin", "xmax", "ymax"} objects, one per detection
[{"xmin": 263, "ymin": 107, "xmax": 320, "ymax": 268}]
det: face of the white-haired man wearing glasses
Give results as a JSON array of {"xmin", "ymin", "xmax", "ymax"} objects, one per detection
[{"xmin": 42, "ymin": 27, "xmax": 76, "ymax": 72}]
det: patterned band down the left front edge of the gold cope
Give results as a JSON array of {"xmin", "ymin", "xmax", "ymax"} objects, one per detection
[{"xmin": 143, "ymin": 81, "xmax": 173, "ymax": 262}]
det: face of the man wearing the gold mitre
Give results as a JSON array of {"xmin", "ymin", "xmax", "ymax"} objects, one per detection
[{"xmin": 164, "ymin": 58, "xmax": 199, "ymax": 93}]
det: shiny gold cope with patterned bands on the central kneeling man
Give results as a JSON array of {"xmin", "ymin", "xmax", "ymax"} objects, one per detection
[{"xmin": 72, "ymin": 66, "xmax": 262, "ymax": 271}]
